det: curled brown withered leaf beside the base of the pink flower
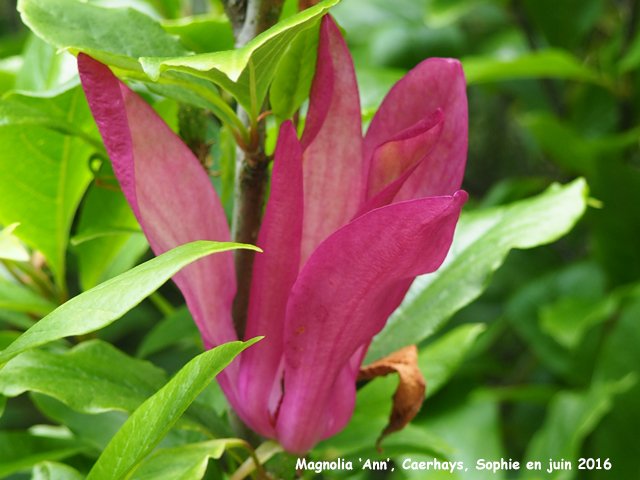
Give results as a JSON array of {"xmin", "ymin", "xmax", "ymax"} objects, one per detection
[{"xmin": 358, "ymin": 345, "xmax": 427, "ymax": 452}]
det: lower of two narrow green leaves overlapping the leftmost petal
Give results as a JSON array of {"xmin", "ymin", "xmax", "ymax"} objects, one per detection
[{"xmin": 87, "ymin": 338, "xmax": 259, "ymax": 480}]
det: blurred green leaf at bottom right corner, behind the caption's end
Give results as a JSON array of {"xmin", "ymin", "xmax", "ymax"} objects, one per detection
[{"xmin": 524, "ymin": 375, "xmax": 635, "ymax": 480}]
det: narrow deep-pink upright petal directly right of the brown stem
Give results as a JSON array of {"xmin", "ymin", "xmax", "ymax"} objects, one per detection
[{"xmin": 238, "ymin": 121, "xmax": 303, "ymax": 438}]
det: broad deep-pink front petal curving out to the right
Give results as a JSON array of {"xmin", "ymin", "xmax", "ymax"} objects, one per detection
[{"xmin": 276, "ymin": 192, "xmax": 467, "ymax": 454}]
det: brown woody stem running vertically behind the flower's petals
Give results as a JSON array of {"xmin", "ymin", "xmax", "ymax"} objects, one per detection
[{"xmin": 224, "ymin": 0, "xmax": 284, "ymax": 340}]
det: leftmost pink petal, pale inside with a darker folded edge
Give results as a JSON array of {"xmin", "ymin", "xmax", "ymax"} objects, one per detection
[{"xmin": 78, "ymin": 53, "xmax": 237, "ymax": 397}]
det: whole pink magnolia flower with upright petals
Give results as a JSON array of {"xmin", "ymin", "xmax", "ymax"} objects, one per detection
[{"xmin": 78, "ymin": 16, "xmax": 467, "ymax": 454}]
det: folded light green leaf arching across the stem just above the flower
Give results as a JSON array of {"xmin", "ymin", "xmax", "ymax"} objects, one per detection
[{"xmin": 140, "ymin": 0, "xmax": 339, "ymax": 112}]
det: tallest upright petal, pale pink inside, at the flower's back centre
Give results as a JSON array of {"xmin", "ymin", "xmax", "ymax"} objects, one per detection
[{"xmin": 301, "ymin": 15, "xmax": 363, "ymax": 265}]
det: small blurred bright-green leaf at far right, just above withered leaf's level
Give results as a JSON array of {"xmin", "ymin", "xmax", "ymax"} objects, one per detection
[{"xmin": 540, "ymin": 296, "xmax": 618, "ymax": 349}]
